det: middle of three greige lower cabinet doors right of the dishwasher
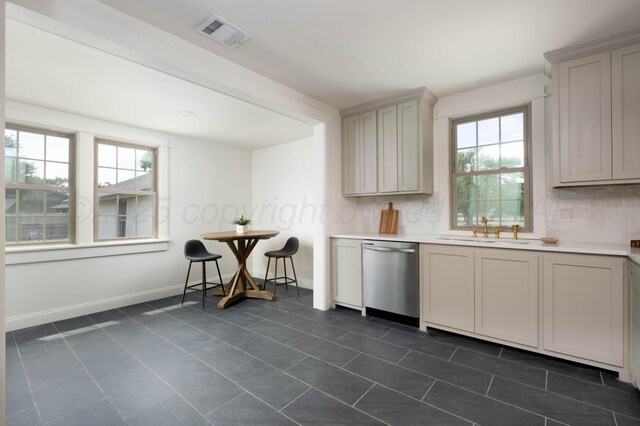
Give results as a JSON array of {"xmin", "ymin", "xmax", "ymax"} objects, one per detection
[{"xmin": 475, "ymin": 249, "xmax": 538, "ymax": 347}]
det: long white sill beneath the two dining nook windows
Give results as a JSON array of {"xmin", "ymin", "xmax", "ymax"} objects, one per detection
[{"xmin": 5, "ymin": 239, "xmax": 169, "ymax": 265}]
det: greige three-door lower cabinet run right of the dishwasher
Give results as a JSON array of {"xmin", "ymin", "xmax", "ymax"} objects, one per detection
[{"xmin": 420, "ymin": 244, "xmax": 628, "ymax": 379}]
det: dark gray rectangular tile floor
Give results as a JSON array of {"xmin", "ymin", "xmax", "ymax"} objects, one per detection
[{"xmin": 6, "ymin": 290, "xmax": 640, "ymax": 426}]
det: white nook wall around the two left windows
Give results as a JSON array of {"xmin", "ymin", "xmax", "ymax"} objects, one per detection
[{"xmin": 5, "ymin": 102, "xmax": 251, "ymax": 330}]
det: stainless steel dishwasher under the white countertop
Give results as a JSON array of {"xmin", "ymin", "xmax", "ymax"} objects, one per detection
[{"xmin": 363, "ymin": 240, "xmax": 419, "ymax": 318}]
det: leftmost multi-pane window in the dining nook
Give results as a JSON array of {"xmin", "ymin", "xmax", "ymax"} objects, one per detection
[{"xmin": 4, "ymin": 125, "xmax": 74, "ymax": 245}]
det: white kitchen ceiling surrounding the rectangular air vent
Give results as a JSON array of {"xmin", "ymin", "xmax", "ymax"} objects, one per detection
[{"xmin": 94, "ymin": 0, "xmax": 640, "ymax": 108}]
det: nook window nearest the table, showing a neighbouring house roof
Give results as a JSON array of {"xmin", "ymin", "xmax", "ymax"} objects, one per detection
[{"xmin": 94, "ymin": 140, "xmax": 157, "ymax": 240}]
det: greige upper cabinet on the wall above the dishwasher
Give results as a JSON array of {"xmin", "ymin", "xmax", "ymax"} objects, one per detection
[{"xmin": 341, "ymin": 89, "xmax": 435, "ymax": 196}]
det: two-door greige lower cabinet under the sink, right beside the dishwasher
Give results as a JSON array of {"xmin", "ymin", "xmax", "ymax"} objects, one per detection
[{"xmin": 421, "ymin": 245, "xmax": 538, "ymax": 347}]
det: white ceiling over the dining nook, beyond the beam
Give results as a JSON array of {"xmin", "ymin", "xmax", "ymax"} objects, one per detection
[{"xmin": 5, "ymin": 19, "xmax": 313, "ymax": 150}]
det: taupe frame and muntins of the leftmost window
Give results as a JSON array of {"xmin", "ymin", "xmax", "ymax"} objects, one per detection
[{"xmin": 3, "ymin": 122, "xmax": 77, "ymax": 248}]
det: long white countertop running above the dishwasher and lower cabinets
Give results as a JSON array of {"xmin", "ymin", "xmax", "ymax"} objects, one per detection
[{"xmin": 332, "ymin": 233, "xmax": 640, "ymax": 265}]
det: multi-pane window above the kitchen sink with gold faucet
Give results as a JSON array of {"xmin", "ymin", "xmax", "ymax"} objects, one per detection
[{"xmin": 451, "ymin": 106, "xmax": 532, "ymax": 231}]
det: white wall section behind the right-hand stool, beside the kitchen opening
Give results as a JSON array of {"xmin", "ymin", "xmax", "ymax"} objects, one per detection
[{"xmin": 251, "ymin": 138, "xmax": 322, "ymax": 288}]
